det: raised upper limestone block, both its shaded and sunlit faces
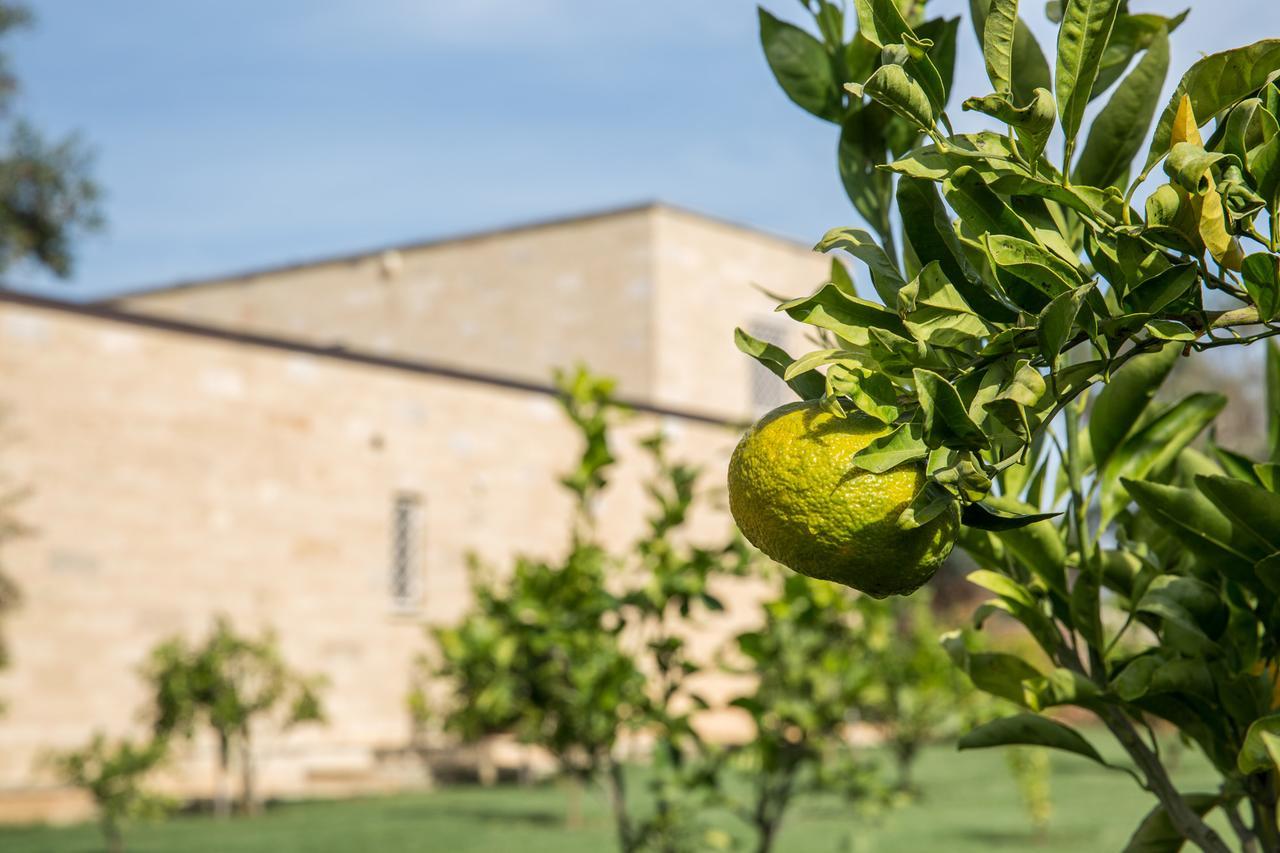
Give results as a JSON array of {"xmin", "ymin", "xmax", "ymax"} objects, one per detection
[{"xmin": 116, "ymin": 205, "xmax": 828, "ymax": 419}]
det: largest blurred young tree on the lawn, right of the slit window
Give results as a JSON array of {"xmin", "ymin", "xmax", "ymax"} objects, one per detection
[{"xmin": 429, "ymin": 370, "xmax": 748, "ymax": 850}]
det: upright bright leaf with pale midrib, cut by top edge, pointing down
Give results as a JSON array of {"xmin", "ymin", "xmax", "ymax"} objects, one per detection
[{"xmin": 1053, "ymin": 0, "xmax": 1120, "ymax": 164}]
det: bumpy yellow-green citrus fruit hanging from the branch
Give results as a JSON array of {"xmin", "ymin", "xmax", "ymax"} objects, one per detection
[{"xmin": 728, "ymin": 402, "xmax": 959, "ymax": 598}]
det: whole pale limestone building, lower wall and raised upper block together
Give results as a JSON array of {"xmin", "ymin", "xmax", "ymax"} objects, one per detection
[{"xmin": 0, "ymin": 206, "xmax": 827, "ymax": 820}]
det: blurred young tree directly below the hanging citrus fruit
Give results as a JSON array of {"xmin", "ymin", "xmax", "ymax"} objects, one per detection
[{"xmin": 733, "ymin": 575, "xmax": 888, "ymax": 853}]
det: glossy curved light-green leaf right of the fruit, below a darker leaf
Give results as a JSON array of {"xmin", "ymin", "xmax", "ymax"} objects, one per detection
[{"xmin": 1101, "ymin": 393, "xmax": 1226, "ymax": 525}]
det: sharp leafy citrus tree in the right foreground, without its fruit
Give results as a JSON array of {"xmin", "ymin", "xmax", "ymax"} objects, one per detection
[{"xmin": 739, "ymin": 0, "xmax": 1280, "ymax": 852}]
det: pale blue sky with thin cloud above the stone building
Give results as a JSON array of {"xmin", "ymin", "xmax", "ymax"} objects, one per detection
[{"xmin": 9, "ymin": 0, "xmax": 1280, "ymax": 298}]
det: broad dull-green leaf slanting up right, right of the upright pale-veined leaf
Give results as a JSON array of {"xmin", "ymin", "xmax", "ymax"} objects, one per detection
[{"xmin": 1073, "ymin": 28, "xmax": 1169, "ymax": 187}]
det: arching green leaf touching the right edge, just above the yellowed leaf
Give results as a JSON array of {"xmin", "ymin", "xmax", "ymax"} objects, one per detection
[{"xmin": 1143, "ymin": 38, "xmax": 1280, "ymax": 174}]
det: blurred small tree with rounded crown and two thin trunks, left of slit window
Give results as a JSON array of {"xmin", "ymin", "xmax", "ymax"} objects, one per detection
[{"xmin": 145, "ymin": 617, "xmax": 324, "ymax": 816}]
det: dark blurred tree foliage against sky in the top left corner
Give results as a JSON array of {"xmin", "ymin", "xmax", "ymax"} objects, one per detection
[{"xmin": 0, "ymin": 3, "xmax": 102, "ymax": 277}]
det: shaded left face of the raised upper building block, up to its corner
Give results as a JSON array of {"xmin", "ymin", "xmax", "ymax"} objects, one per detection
[{"xmin": 116, "ymin": 207, "xmax": 654, "ymax": 397}]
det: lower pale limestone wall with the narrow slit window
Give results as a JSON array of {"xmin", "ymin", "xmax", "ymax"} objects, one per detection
[{"xmin": 0, "ymin": 298, "xmax": 760, "ymax": 812}]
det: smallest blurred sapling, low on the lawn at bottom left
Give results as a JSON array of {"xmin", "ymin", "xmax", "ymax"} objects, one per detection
[{"xmin": 52, "ymin": 733, "xmax": 173, "ymax": 853}]
